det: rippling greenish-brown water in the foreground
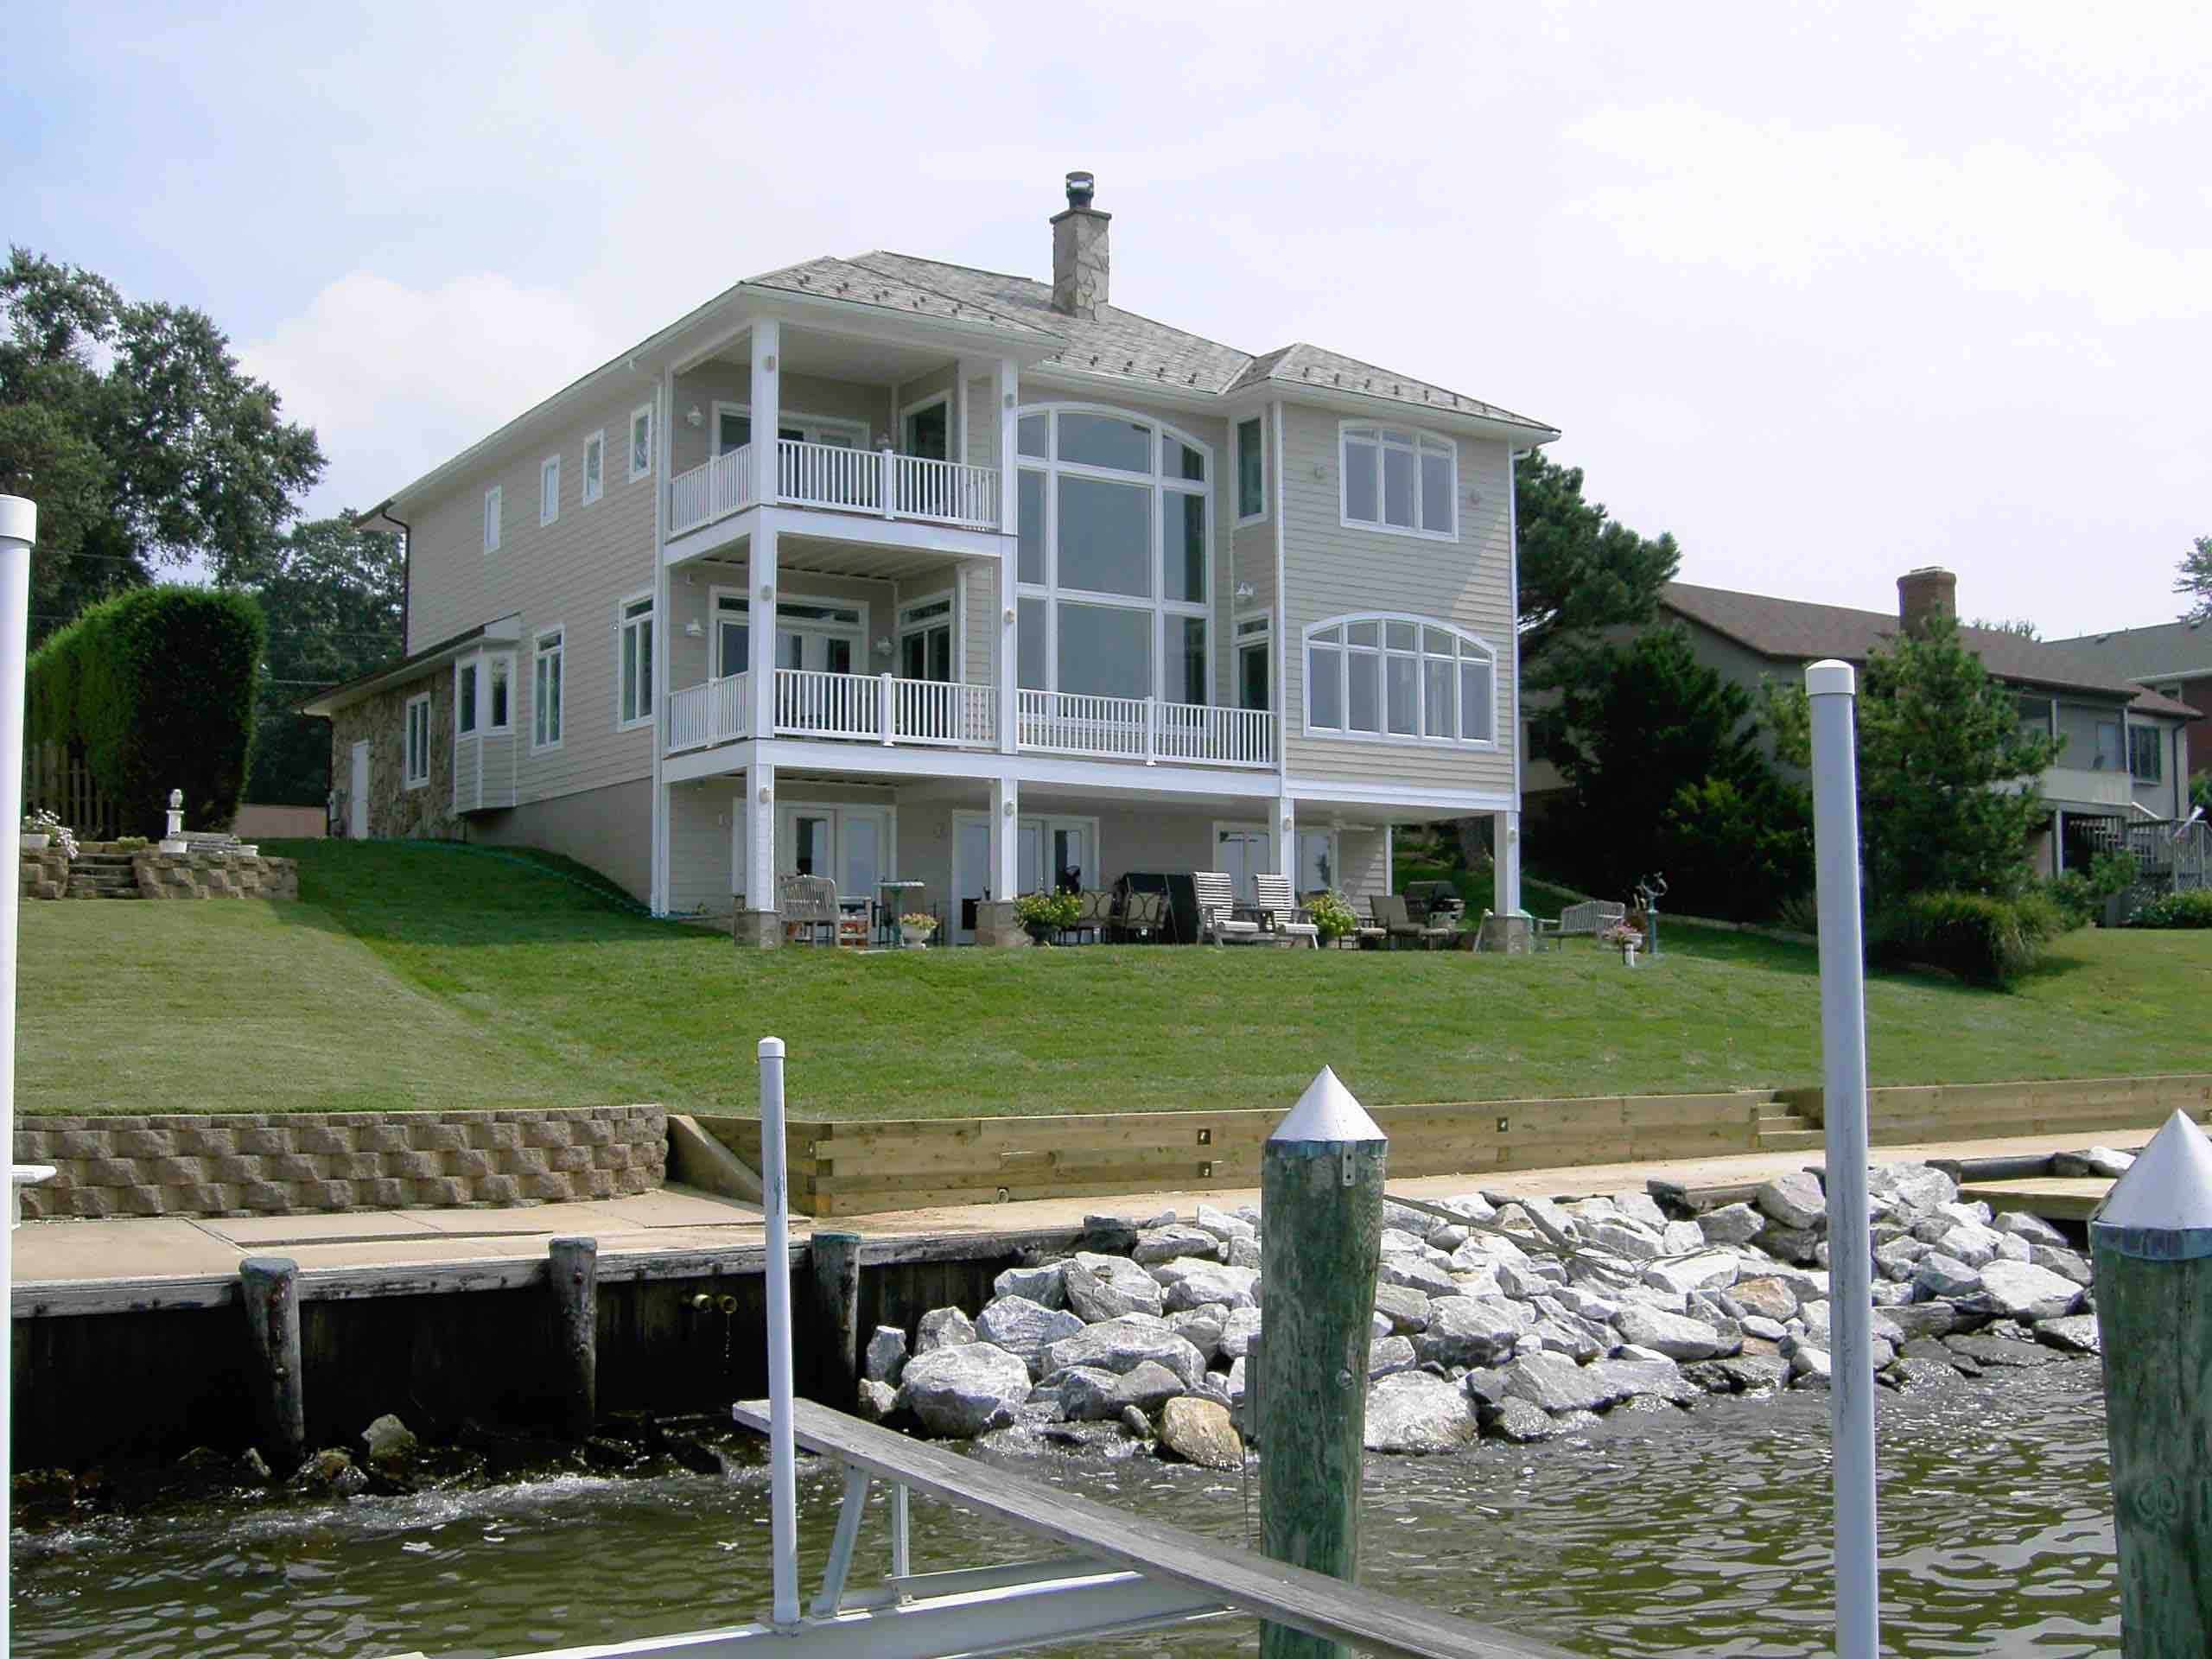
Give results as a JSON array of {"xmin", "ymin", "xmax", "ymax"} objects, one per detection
[{"xmin": 13, "ymin": 1363, "xmax": 2119, "ymax": 1659}]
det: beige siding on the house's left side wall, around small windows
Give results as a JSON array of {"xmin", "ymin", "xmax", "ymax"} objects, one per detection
[{"xmin": 398, "ymin": 376, "xmax": 666, "ymax": 818}]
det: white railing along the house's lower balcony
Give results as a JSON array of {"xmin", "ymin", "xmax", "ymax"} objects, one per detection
[{"xmin": 666, "ymin": 668, "xmax": 1274, "ymax": 767}]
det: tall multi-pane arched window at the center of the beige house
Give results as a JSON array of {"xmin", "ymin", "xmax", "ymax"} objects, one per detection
[{"xmin": 1015, "ymin": 413, "xmax": 1214, "ymax": 703}]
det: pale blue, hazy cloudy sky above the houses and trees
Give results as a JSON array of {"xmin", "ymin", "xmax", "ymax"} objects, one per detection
[{"xmin": 17, "ymin": 0, "xmax": 2212, "ymax": 635}]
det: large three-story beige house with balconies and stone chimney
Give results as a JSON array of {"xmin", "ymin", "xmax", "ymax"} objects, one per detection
[{"xmin": 305, "ymin": 175, "xmax": 1557, "ymax": 943}]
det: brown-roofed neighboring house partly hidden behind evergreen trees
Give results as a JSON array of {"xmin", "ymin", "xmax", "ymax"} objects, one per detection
[{"xmin": 1526, "ymin": 569, "xmax": 2195, "ymax": 874}]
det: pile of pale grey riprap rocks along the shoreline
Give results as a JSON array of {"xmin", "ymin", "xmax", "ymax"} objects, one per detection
[{"xmin": 858, "ymin": 1164, "xmax": 2097, "ymax": 1469}]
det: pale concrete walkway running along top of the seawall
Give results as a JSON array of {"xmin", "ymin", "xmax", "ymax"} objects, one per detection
[{"xmin": 16, "ymin": 1130, "xmax": 2152, "ymax": 1287}]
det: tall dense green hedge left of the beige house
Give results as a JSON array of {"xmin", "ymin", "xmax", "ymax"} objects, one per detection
[{"xmin": 27, "ymin": 586, "xmax": 268, "ymax": 836}]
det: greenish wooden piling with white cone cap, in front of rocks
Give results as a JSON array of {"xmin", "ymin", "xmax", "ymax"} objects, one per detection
[{"xmin": 1248, "ymin": 1066, "xmax": 1389, "ymax": 1659}]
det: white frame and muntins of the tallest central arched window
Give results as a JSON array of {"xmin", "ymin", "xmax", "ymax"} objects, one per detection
[{"xmin": 1008, "ymin": 403, "xmax": 1221, "ymax": 708}]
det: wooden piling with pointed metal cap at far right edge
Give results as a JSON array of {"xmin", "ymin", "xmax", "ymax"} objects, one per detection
[{"xmin": 2088, "ymin": 1110, "xmax": 2212, "ymax": 1659}]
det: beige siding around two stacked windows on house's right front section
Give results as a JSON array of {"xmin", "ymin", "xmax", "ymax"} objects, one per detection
[{"xmin": 1282, "ymin": 404, "xmax": 1520, "ymax": 794}]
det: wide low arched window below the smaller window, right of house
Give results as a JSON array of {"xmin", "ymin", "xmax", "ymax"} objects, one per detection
[{"xmin": 1305, "ymin": 611, "xmax": 1497, "ymax": 746}]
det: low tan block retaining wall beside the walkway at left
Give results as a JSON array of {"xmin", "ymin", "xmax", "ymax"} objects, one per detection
[{"xmin": 16, "ymin": 1106, "xmax": 668, "ymax": 1219}]
